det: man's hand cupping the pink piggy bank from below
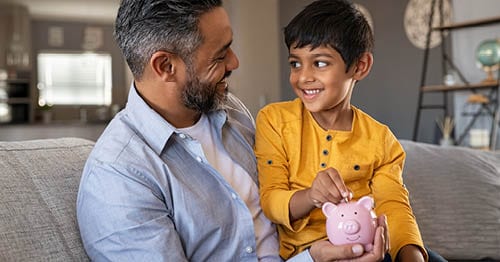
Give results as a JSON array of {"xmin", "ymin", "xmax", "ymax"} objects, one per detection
[{"xmin": 309, "ymin": 215, "xmax": 389, "ymax": 262}]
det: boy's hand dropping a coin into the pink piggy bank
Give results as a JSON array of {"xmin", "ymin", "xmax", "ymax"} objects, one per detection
[{"xmin": 307, "ymin": 167, "xmax": 352, "ymax": 208}]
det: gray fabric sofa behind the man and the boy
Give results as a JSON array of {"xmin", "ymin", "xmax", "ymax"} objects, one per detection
[{"xmin": 0, "ymin": 138, "xmax": 500, "ymax": 261}]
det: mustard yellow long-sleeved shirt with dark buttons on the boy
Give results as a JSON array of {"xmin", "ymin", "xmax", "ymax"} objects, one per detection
[{"xmin": 255, "ymin": 99, "xmax": 427, "ymax": 259}]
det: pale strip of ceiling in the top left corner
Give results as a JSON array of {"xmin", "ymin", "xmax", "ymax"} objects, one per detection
[{"xmin": 0, "ymin": 0, "xmax": 120, "ymax": 23}]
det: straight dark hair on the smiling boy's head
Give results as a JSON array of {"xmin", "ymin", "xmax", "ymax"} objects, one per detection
[{"xmin": 285, "ymin": 0, "xmax": 374, "ymax": 71}]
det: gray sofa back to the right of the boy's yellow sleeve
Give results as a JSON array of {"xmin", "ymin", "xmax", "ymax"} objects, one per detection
[{"xmin": 401, "ymin": 140, "xmax": 500, "ymax": 261}]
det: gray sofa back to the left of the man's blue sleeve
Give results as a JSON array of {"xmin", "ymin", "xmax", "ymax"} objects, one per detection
[{"xmin": 0, "ymin": 138, "xmax": 94, "ymax": 261}]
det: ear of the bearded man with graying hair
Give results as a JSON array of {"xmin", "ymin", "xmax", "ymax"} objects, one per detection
[{"xmin": 149, "ymin": 51, "xmax": 180, "ymax": 82}]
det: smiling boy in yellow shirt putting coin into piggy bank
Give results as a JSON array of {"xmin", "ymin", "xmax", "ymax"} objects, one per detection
[{"xmin": 255, "ymin": 0, "xmax": 427, "ymax": 261}]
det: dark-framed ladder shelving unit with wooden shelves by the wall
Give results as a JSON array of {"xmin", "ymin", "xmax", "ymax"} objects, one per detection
[{"xmin": 413, "ymin": 0, "xmax": 500, "ymax": 150}]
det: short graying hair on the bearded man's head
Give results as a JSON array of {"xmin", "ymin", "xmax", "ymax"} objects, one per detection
[{"xmin": 114, "ymin": 0, "xmax": 222, "ymax": 79}]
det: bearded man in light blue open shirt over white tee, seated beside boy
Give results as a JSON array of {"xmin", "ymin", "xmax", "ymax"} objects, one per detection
[{"xmin": 77, "ymin": 0, "xmax": 386, "ymax": 261}]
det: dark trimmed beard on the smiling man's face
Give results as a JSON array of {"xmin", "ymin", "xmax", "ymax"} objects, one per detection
[{"xmin": 182, "ymin": 69, "xmax": 230, "ymax": 113}]
